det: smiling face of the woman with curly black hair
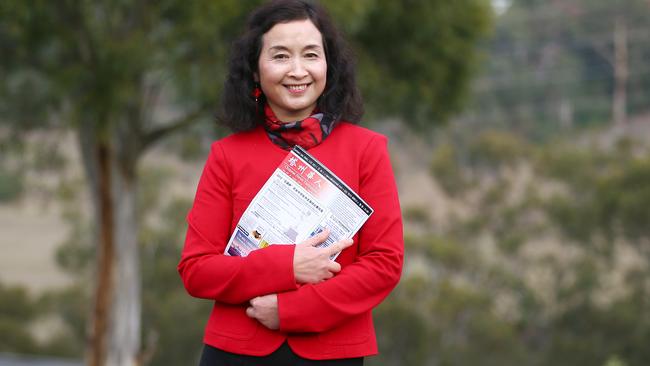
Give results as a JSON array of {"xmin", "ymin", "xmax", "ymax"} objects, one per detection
[{"xmin": 256, "ymin": 19, "xmax": 327, "ymax": 122}]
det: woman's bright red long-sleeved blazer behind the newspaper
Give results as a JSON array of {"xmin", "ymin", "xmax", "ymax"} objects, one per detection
[{"xmin": 178, "ymin": 123, "xmax": 404, "ymax": 359}]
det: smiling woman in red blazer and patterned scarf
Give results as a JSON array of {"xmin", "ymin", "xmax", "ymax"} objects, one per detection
[{"xmin": 178, "ymin": 0, "xmax": 403, "ymax": 365}]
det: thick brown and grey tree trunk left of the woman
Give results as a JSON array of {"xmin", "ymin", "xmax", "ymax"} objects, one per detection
[{"xmin": 79, "ymin": 123, "xmax": 141, "ymax": 366}]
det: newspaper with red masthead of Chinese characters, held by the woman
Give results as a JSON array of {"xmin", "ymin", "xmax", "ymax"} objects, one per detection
[{"xmin": 225, "ymin": 146, "xmax": 373, "ymax": 259}]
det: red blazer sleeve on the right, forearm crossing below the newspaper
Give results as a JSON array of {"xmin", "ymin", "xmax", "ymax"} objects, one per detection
[{"xmin": 278, "ymin": 135, "xmax": 404, "ymax": 332}]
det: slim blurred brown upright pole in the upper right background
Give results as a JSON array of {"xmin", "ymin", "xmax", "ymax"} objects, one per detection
[{"xmin": 612, "ymin": 16, "xmax": 628, "ymax": 126}]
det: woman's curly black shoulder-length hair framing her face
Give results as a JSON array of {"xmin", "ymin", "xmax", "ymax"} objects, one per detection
[{"xmin": 217, "ymin": 0, "xmax": 363, "ymax": 132}]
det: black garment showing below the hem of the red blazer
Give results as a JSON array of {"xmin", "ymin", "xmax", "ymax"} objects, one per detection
[{"xmin": 199, "ymin": 342, "xmax": 363, "ymax": 366}]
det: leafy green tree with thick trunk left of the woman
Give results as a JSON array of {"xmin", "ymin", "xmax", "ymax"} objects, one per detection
[{"xmin": 0, "ymin": 0, "xmax": 254, "ymax": 365}]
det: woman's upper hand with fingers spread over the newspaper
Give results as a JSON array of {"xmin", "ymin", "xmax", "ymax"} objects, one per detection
[{"xmin": 293, "ymin": 230, "xmax": 353, "ymax": 283}]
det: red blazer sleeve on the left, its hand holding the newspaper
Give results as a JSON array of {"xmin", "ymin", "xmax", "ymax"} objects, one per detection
[{"xmin": 178, "ymin": 142, "xmax": 297, "ymax": 304}]
